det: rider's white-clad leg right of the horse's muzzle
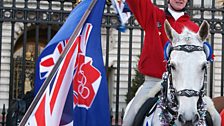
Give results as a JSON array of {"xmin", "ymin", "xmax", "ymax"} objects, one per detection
[{"xmin": 203, "ymin": 96, "xmax": 221, "ymax": 126}]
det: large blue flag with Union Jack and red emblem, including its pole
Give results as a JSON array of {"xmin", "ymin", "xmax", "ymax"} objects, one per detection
[{"xmin": 20, "ymin": 0, "xmax": 110, "ymax": 126}]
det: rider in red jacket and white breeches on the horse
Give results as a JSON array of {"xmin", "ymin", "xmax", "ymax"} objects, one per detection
[{"xmin": 123, "ymin": 0, "xmax": 220, "ymax": 126}]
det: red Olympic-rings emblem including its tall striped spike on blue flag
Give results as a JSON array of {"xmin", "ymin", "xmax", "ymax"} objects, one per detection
[{"xmin": 73, "ymin": 23, "xmax": 101, "ymax": 109}]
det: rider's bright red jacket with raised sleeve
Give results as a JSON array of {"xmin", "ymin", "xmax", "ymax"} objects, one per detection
[{"xmin": 126, "ymin": 0, "xmax": 199, "ymax": 78}]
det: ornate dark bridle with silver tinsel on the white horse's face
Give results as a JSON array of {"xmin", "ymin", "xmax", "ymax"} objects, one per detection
[{"xmin": 158, "ymin": 45, "xmax": 207, "ymax": 126}]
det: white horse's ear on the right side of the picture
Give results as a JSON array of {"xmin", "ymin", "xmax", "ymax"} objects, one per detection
[{"xmin": 198, "ymin": 20, "xmax": 209, "ymax": 41}]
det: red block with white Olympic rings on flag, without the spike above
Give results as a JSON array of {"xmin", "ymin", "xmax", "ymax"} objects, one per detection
[{"xmin": 73, "ymin": 54, "xmax": 101, "ymax": 108}]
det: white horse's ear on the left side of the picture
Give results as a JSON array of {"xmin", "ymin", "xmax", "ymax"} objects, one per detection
[{"xmin": 164, "ymin": 20, "xmax": 177, "ymax": 41}]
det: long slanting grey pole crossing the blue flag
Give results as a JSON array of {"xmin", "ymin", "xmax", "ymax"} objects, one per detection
[{"xmin": 19, "ymin": 0, "xmax": 97, "ymax": 126}]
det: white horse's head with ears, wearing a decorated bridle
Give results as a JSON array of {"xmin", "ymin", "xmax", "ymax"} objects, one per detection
[{"xmin": 165, "ymin": 21, "xmax": 211, "ymax": 125}]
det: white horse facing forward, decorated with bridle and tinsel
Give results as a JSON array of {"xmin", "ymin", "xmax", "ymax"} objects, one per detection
[{"xmin": 123, "ymin": 21, "xmax": 221, "ymax": 126}]
